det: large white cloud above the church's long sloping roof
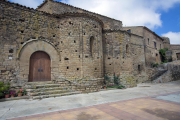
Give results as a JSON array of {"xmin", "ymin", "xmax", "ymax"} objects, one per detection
[{"xmin": 66, "ymin": 0, "xmax": 180, "ymax": 29}]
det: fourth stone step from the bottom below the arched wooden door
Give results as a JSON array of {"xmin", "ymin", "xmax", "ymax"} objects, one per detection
[{"xmin": 26, "ymin": 84, "xmax": 61, "ymax": 89}]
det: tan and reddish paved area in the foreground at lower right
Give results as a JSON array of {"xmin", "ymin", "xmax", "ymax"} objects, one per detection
[{"xmin": 8, "ymin": 92, "xmax": 180, "ymax": 120}]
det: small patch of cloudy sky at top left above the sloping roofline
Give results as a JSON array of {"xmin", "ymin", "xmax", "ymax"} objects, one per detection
[{"xmin": 9, "ymin": 0, "xmax": 43, "ymax": 9}]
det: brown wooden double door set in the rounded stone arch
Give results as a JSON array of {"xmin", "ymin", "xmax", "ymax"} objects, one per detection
[{"xmin": 29, "ymin": 51, "xmax": 51, "ymax": 82}]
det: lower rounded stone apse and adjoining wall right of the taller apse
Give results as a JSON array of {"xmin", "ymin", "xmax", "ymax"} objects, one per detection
[{"xmin": 103, "ymin": 30, "xmax": 147, "ymax": 87}]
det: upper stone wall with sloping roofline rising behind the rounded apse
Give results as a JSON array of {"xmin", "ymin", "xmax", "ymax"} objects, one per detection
[{"xmin": 38, "ymin": 0, "xmax": 122, "ymax": 29}]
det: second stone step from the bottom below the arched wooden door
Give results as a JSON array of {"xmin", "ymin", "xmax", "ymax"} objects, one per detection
[{"xmin": 29, "ymin": 90, "xmax": 72, "ymax": 96}]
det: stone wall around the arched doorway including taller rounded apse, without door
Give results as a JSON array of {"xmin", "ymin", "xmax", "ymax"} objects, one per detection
[{"xmin": 0, "ymin": 0, "xmax": 103, "ymax": 86}]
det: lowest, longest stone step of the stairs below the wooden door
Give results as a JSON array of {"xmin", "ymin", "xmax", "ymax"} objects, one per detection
[{"xmin": 31, "ymin": 91, "xmax": 81, "ymax": 100}]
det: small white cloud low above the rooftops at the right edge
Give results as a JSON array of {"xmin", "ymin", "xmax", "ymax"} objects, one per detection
[{"xmin": 162, "ymin": 32, "xmax": 180, "ymax": 44}]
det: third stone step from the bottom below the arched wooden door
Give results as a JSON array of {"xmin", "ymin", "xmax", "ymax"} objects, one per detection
[{"xmin": 26, "ymin": 87, "xmax": 67, "ymax": 92}]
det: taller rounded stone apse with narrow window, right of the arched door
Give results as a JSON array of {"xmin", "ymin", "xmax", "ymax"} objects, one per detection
[{"xmin": 58, "ymin": 15, "xmax": 103, "ymax": 79}]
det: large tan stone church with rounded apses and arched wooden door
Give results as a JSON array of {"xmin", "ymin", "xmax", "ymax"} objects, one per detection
[{"xmin": 0, "ymin": 0, "xmax": 180, "ymax": 97}]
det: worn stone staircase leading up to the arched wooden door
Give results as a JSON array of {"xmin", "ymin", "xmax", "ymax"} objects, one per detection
[{"xmin": 25, "ymin": 81, "xmax": 81, "ymax": 99}]
